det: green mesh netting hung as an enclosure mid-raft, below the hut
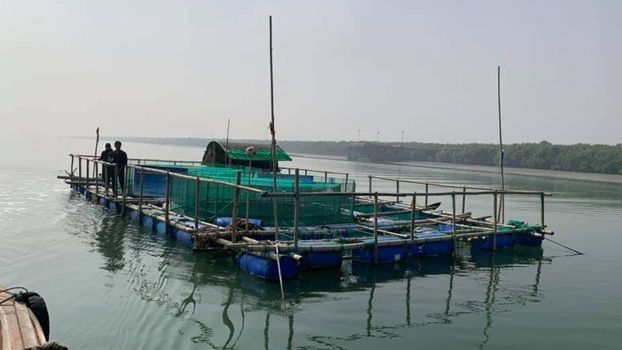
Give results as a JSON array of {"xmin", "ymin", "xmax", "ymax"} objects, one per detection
[{"xmin": 171, "ymin": 166, "xmax": 355, "ymax": 227}]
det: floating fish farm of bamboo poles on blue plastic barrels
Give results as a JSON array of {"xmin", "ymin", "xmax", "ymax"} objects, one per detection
[{"xmin": 59, "ymin": 152, "xmax": 553, "ymax": 281}]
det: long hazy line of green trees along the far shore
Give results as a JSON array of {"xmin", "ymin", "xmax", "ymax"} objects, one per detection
[{"xmin": 109, "ymin": 137, "xmax": 622, "ymax": 174}]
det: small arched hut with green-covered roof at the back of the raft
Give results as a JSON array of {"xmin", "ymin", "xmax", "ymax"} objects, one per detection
[{"xmin": 201, "ymin": 141, "xmax": 292, "ymax": 169}]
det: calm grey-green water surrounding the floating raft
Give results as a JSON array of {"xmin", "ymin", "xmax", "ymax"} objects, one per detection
[{"xmin": 0, "ymin": 139, "xmax": 622, "ymax": 350}]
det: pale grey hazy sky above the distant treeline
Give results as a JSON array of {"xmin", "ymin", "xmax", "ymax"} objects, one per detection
[{"xmin": 0, "ymin": 0, "xmax": 622, "ymax": 143}]
